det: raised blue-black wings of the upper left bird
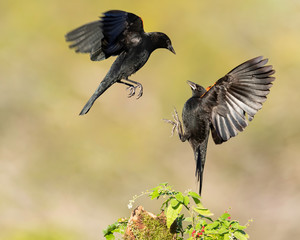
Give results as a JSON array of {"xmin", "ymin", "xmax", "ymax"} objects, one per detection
[{"xmin": 65, "ymin": 10, "xmax": 144, "ymax": 61}]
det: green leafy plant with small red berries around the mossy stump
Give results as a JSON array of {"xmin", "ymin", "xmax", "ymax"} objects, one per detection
[{"xmin": 103, "ymin": 183, "xmax": 249, "ymax": 240}]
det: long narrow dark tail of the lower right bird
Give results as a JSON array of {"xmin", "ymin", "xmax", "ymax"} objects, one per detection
[{"xmin": 194, "ymin": 134, "xmax": 209, "ymax": 196}]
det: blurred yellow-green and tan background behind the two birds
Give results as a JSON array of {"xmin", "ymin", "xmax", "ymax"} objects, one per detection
[{"xmin": 0, "ymin": 0, "xmax": 300, "ymax": 240}]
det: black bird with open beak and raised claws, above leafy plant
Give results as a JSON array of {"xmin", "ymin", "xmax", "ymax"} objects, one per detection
[{"xmin": 165, "ymin": 57, "xmax": 275, "ymax": 195}]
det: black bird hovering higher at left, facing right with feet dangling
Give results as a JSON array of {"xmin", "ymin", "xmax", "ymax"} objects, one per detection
[{"xmin": 65, "ymin": 10, "xmax": 175, "ymax": 115}]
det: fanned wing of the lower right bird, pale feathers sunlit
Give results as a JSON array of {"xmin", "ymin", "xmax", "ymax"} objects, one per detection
[{"xmin": 202, "ymin": 56, "xmax": 275, "ymax": 144}]
